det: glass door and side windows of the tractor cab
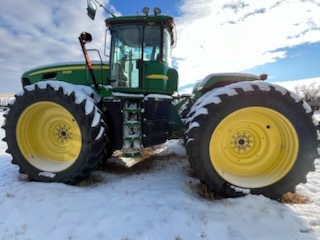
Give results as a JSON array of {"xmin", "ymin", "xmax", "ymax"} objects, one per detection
[{"xmin": 110, "ymin": 24, "xmax": 171, "ymax": 88}]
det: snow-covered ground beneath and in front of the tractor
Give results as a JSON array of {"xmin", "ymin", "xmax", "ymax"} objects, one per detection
[{"xmin": 0, "ymin": 112, "xmax": 320, "ymax": 240}]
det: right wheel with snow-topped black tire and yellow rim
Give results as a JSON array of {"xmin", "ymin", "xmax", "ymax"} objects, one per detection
[{"xmin": 186, "ymin": 81, "xmax": 318, "ymax": 199}]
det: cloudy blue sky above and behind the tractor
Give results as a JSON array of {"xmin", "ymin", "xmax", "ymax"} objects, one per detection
[{"xmin": 0, "ymin": 0, "xmax": 320, "ymax": 93}]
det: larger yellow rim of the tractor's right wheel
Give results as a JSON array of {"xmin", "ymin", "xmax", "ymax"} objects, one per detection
[{"xmin": 209, "ymin": 107, "xmax": 299, "ymax": 188}]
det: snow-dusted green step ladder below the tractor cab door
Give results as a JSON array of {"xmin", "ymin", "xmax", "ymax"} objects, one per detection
[{"xmin": 122, "ymin": 99, "xmax": 143, "ymax": 157}]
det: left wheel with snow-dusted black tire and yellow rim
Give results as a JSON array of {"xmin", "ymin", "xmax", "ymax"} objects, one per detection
[{"xmin": 3, "ymin": 82, "xmax": 108, "ymax": 184}]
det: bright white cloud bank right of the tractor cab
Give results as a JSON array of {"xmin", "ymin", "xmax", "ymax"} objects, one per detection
[{"xmin": 173, "ymin": 0, "xmax": 320, "ymax": 86}]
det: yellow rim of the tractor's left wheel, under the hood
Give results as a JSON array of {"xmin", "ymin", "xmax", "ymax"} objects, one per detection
[{"xmin": 16, "ymin": 101, "xmax": 82, "ymax": 172}]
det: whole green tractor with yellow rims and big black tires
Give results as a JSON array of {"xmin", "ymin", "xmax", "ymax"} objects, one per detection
[{"xmin": 3, "ymin": 1, "xmax": 318, "ymax": 199}]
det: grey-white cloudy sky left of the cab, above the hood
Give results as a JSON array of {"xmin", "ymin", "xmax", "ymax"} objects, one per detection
[{"xmin": 0, "ymin": 0, "xmax": 112, "ymax": 93}]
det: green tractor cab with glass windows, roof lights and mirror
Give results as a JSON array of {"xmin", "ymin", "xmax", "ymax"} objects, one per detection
[{"xmin": 88, "ymin": 1, "xmax": 178, "ymax": 94}]
